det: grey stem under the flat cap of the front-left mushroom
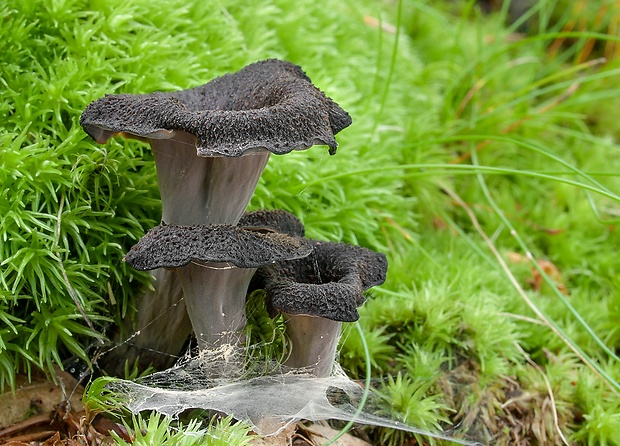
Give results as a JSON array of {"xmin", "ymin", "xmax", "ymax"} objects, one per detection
[{"xmin": 177, "ymin": 263, "xmax": 256, "ymax": 350}]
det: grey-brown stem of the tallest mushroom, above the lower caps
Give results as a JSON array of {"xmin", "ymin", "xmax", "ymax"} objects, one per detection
[{"xmin": 150, "ymin": 130, "xmax": 271, "ymax": 225}]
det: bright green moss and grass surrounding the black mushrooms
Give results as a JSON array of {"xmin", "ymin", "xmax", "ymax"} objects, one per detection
[{"xmin": 0, "ymin": 0, "xmax": 620, "ymax": 444}]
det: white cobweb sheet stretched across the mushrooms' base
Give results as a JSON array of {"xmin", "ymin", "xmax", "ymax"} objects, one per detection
[{"xmin": 108, "ymin": 345, "xmax": 480, "ymax": 445}]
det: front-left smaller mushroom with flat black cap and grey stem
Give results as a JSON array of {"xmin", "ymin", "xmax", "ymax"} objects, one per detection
[{"xmin": 125, "ymin": 224, "xmax": 312, "ymax": 350}]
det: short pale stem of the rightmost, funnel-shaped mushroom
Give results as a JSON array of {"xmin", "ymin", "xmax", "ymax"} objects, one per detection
[{"xmin": 285, "ymin": 314, "xmax": 342, "ymax": 378}]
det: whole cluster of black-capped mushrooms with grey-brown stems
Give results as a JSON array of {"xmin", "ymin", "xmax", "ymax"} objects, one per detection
[{"xmin": 80, "ymin": 59, "xmax": 387, "ymax": 375}]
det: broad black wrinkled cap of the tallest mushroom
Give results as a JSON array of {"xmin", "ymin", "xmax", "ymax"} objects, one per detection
[{"xmin": 80, "ymin": 59, "xmax": 351, "ymax": 156}]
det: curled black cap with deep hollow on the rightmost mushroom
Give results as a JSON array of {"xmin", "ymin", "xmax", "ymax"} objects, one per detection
[{"xmin": 253, "ymin": 240, "xmax": 387, "ymax": 322}]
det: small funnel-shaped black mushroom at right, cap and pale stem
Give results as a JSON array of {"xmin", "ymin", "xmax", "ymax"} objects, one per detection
[{"xmin": 253, "ymin": 240, "xmax": 387, "ymax": 377}]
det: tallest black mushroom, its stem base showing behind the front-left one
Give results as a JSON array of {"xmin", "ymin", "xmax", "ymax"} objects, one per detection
[{"xmin": 80, "ymin": 59, "xmax": 351, "ymax": 366}]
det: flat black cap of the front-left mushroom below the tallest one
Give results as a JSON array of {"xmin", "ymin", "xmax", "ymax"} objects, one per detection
[{"xmin": 125, "ymin": 224, "xmax": 312, "ymax": 271}]
